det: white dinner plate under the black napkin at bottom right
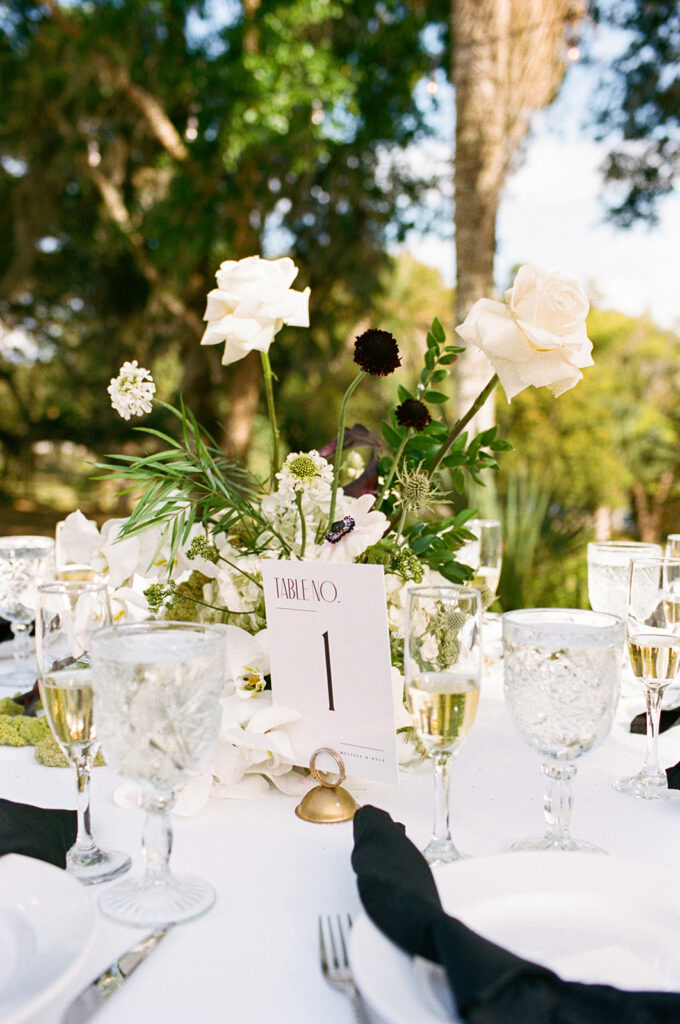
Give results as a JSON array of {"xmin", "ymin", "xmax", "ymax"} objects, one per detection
[{"xmin": 349, "ymin": 853, "xmax": 680, "ymax": 1024}]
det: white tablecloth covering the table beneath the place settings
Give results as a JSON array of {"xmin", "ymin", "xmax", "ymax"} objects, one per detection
[{"xmin": 0, "ymin": 647, "xmax": 680, "ymax": 1024}]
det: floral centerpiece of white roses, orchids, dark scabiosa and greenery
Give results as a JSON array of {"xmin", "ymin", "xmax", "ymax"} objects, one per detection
[{"xmin": 61, "ymin": 256, "xmax": 592, "ymax": 799}]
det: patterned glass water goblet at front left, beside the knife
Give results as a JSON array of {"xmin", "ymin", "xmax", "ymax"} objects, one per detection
[{"xmin": 92, "ymin": 622, "xmax": 226, "ymax": 928}]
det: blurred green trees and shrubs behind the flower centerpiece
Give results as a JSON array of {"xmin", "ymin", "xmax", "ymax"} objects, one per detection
[{"xmin": 0, "ymin": 0, "xmax": 680, "ymax": 607}]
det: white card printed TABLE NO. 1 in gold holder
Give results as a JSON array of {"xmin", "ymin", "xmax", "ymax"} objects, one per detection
[{"xmin": 261, "ymin": 559, "xmax": 397, "ymax": 782}]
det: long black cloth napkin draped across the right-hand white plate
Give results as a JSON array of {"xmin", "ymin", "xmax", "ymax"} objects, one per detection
[{"xmin": 352, "ymin": 805, "xmax": 680, "ymax": 1024}]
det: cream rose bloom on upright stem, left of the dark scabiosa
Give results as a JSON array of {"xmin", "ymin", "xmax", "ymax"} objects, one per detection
[{"xmin": 201, "ymin": 256, "xmax": 309, "ymax": 364}]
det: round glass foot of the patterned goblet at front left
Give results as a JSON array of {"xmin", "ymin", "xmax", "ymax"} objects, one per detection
[{"xmin": 99, "ymin": 874, "xmax": 216, "ymax": 928}]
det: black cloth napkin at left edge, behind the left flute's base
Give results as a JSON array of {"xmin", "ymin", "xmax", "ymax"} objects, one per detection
[{"xmin": 0, "ymin": 800, "xmax": 77, "ymax": 867}]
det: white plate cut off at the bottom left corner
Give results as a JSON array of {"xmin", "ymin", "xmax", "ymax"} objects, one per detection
[{"xmin": 0, "ymin": 853, "xmax": 96, "ymax": 1024}]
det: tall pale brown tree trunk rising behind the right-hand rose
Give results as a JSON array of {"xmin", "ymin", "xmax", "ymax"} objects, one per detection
[{"xmin": 452, "ymin": 0, "xmax": 585, "ymax": 432}]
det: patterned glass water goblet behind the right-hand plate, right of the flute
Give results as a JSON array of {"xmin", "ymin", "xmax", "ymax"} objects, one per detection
[{"xmin": 503, "ymin": 608, "xmax": 626, "ymax": 852}]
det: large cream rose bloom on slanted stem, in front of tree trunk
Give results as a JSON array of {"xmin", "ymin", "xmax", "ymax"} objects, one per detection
[{"xmin": 458, "ymin": 264, "xmax": 593, "ymax": 401}]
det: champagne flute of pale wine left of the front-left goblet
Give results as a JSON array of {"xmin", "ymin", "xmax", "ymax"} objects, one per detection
[{"xmin": 36, "ymin": 581, "xmax": 131, "ymax": 885}]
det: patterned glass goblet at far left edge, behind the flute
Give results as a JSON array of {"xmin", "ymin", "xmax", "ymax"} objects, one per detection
[{"xmin": 0, "ymin": 537, "xmax": 54, "ymax": 689}]
